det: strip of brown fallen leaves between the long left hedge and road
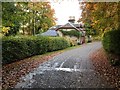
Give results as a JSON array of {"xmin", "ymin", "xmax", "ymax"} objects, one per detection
[{"xmin": 2, "ymin": 52, "xmax": 61, "ymax": 89}]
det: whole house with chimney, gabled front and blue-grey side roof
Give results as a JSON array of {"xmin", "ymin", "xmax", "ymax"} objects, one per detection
[{"xmin": 41, "ymin": 17, "xmax": 85, "ymax": 44}]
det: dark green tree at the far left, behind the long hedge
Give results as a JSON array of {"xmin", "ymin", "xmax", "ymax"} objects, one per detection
[{"xmin": 2, "ymin": 2, "xmax": 21, "ymax": 36}]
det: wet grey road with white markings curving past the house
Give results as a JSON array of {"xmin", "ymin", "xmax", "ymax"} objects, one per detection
[{"xmin": 15, "ymin": 42, "xmax": 111, "ymax": 88}]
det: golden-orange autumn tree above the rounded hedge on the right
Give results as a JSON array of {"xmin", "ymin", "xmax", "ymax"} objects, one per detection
[{"xmin": 80, "ymin": 2, "xmax": 119, "ymax": 35}]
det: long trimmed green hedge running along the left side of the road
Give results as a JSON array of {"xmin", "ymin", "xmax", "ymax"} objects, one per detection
[{"xmin": 2, "ymin": 36, "xmax": 70, "ymax": 64}]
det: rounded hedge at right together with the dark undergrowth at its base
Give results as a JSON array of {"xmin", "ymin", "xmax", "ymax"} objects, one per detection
[{"xmin": 102, "ymin": 30, "xmax": 120, "ymax": 66}]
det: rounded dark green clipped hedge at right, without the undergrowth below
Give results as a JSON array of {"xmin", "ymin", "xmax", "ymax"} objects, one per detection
[{"xmin": 102, "ymin": 30, "xmax": 120, "ymax": 55}]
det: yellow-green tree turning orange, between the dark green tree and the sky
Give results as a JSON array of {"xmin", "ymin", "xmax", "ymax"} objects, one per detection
[{"xmin": 18, "ymin": 2, "xmax": 55, "ymax": 35}]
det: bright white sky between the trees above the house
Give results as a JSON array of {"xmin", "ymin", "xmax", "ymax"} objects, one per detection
[{"xmin": 51, "ymin": 0, "xmax": 81, "ymax": 25}]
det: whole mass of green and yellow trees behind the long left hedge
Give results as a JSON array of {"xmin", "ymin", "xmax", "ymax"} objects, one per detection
[{"xmin": 2, "ymin": 2, "xmax": 56, "ymax": 36}]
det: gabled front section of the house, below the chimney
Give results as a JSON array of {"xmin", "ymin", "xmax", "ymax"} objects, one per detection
[{"xmin": 55, "ymin": 22, "xmax": 85, "ymax": 44}]
